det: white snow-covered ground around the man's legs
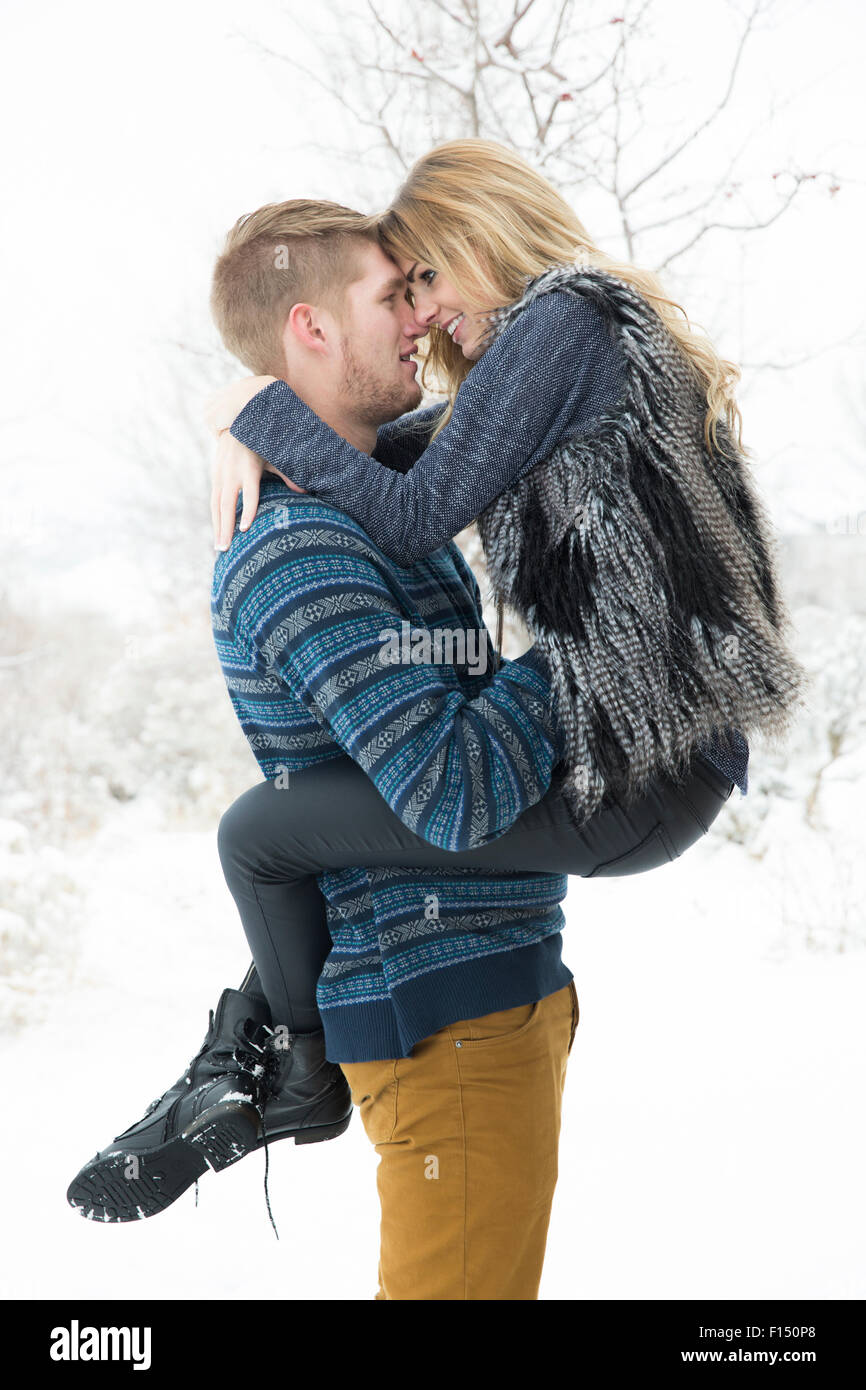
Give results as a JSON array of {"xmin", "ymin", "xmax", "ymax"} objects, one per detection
[{"xmin": 0, "ymin": 792, "xmax": 866, "ymax": 1300}]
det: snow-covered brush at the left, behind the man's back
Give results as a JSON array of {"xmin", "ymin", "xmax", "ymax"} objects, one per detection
[{"xmin": 0, "ymin": 598, "xmax": 254, "ymax": 1027}]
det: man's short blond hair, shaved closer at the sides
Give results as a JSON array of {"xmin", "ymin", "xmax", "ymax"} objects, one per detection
[{"xmin": 210, "ymin": 197, "xmax": 378, "ymax": 377}]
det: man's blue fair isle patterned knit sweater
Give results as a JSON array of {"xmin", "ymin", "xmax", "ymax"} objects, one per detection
[{"xmin": 211, "ymin": 475, "xmax": 571, "ymax": 1062}]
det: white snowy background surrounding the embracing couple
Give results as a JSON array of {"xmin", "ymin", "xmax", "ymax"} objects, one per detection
[{"xmin": 0, "ymin": 0, "xmax": 866, "ymax": 1300}]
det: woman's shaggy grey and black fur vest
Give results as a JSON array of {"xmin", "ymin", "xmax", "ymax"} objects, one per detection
[{"xmin": 478, "ymin": 265, "xmax": 803, "ymax": 821}]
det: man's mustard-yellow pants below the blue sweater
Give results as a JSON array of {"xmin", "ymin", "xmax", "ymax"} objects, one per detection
[{"xmin": 341, "ymin": 981, "xmax": 580, "ymax": 1300}]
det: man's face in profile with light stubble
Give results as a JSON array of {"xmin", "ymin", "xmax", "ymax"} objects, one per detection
[{"xmin": 339, "ymin": 242, "xmax": 427, "ymax": 427}]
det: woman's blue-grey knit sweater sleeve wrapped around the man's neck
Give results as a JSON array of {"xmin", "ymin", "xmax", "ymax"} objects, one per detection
[{"xmin": 232, "ymin": 292, "xmax": 624, "ymax": 564}]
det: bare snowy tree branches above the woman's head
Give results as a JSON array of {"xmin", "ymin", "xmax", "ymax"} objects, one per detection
[{"xmin": 250, "ymin": 0, "xmax": 841, "ymax": 271}]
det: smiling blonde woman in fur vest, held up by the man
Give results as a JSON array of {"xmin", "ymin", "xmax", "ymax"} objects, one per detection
[{"xmin": 201, "ymin": 140, "xmax": 801, "ymax": 1061}]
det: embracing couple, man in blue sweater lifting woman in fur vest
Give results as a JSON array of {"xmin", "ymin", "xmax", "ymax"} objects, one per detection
[{"xmin": 68, "ymin": 140, "xmax": 802, "ymax": 1300}]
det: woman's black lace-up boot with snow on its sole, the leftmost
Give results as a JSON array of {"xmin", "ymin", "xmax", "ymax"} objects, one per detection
[{"xmin": 67, "ymin": 990, "xmax": 271, "ymax": 1222}]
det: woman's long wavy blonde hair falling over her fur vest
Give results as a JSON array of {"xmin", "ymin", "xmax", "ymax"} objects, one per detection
[{"xmin": 378, "ymin": 139, "xmax": 745, "ymax": 452}]
